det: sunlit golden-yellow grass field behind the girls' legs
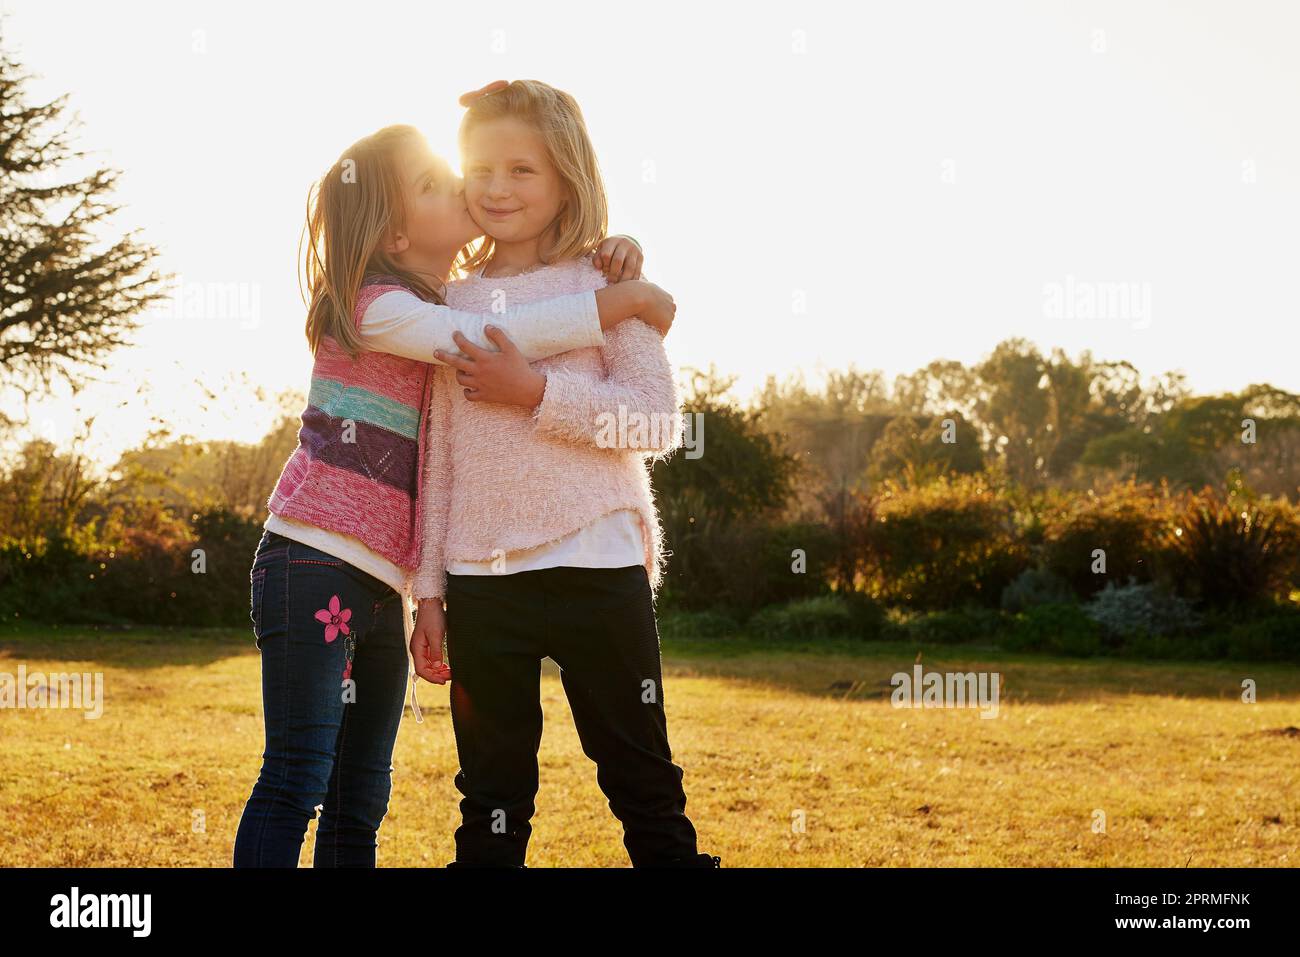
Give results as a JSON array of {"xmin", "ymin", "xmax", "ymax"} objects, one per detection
[{"xmin": 0, "ymin": 628, "xmax": 1300, "ymax": 867}]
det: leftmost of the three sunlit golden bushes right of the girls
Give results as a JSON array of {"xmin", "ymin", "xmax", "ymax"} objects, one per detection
[{"xmin": 868, "ymin": 476, "xmax": 1028, "ymax": 610}]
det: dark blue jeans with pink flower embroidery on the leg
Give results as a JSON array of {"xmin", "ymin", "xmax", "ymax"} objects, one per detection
[{"xmin": 234, "ymin": 532, "xmax": 407, "ymax": 867}]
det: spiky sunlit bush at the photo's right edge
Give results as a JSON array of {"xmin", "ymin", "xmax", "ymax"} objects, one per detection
[{"xmin": 1167, "ymin": 489, "xmax": 1300, "ymax": 607}]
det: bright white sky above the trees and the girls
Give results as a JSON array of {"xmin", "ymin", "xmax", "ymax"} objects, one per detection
[{"xmin": 0, "ymin": 0, "xmax": 1300, "ymax": 456}]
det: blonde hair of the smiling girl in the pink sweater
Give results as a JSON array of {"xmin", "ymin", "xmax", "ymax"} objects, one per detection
[{"xmin": 456, "ymin": 79, "xmax": 608, "ymax": 272}]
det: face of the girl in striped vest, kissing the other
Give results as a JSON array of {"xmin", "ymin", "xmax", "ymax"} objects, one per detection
[{"xmin": 390, "ymin": 147, "xmax": 482, "ymax": 264}]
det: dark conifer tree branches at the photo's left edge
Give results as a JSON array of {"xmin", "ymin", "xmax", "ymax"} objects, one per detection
[{"xmin": 0, "ymin": 40, "xmax": 164, "ymax": 394}]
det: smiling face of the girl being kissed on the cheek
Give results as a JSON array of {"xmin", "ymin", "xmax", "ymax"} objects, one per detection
[{"xmin": 464, "ymin": 117, "xmax": 568, "ymax": 243}]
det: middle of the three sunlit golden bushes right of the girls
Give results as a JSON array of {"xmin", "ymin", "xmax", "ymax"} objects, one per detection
[{"xmin": 1043, "ymin": 482, "xmax": 1170, "ymax": 598}]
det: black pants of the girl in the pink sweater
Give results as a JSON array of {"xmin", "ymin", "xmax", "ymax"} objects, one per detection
[{"xmin": 447, "ymin": 566, "xmax": 697, "ymax": 867}]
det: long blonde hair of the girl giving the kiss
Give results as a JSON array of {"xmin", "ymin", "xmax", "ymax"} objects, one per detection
[{"xmin": 298, "ymin": 125, "xmax": 445, "ymax": 359}]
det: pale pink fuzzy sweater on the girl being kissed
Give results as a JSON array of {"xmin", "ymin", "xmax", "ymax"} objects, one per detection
[{"xmin": 413, "ymin": 257, "xmax": 681, "ymax": 598}]
